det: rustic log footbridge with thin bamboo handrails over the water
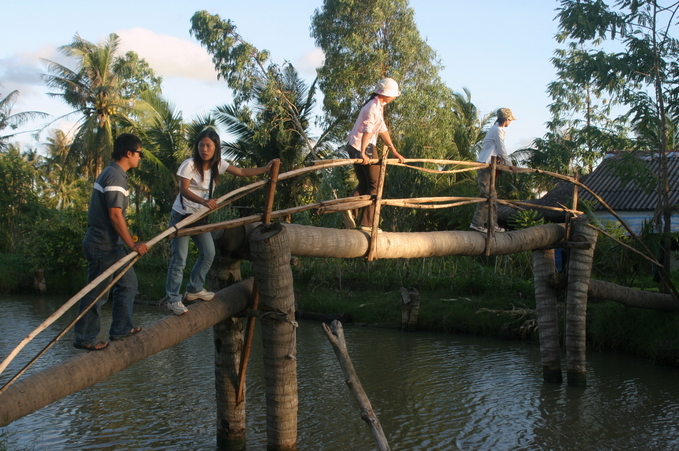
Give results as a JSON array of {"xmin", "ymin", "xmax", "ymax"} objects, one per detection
[{"xmin": 0, "ymin": 154, "xmax": 679, "ymax": 450}]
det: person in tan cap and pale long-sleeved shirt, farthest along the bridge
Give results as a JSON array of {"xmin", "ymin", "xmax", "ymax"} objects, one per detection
[{"xmin": 469, "ymin": 108, "xmax": 516, "ymax": 233}]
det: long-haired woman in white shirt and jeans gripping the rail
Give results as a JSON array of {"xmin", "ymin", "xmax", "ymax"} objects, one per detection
[{"xmin": 165, "ymin": 128, "xmax": 273, "ymax": 315}]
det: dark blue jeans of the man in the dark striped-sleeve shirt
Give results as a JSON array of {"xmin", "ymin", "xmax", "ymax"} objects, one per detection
[{"xmin": 75, "ymin": 244, "xmax": 137, "ymax": 345}]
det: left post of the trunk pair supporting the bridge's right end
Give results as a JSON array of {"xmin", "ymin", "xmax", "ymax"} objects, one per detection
[{"xmin": 533, "ymin": 249, "xmax": 563, "ymax": 383}]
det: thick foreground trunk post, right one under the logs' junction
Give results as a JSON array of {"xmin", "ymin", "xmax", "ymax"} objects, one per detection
[{"xmin": 250, "ymin": 223, "xmax": 298, "ymax": 451}]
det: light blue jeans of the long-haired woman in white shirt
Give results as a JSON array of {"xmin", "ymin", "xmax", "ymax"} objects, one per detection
[{"xmin": 165, "ymin": 210, "xmax": 215, "ymax": 303}]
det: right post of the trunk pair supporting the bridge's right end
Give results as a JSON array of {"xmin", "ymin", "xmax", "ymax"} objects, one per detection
[{"xmin": 565, "ymin": 217, "xmax": 597, "ymax": 386}]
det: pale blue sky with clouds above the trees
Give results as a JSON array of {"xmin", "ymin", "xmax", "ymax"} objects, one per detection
[{"xmin": 0, "ymin": 0, "xmax": 559, "ymax": 152}]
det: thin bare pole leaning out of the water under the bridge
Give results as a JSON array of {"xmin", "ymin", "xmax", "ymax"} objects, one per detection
[{"xmin": 323, "ymin": 320, "xmax": 390, "ymax": 451}]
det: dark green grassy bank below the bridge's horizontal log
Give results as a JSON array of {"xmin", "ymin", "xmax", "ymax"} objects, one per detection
[{"xmin": 293, "ymin": 255, "xmax": 679, "ymax": 366}]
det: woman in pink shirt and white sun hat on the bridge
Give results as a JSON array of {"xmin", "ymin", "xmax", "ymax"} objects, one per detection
[{"xmin": 346, "ymin": 78, "xmax": 405, "ymax": 232}]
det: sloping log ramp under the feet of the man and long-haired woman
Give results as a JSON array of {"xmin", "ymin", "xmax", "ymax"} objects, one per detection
[{"xmin": 0, "ymin": 279, "xmax": 253, "ymax": 427}]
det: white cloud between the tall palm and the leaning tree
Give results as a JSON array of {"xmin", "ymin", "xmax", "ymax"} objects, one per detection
[{"xmin": 116, "ymin": 28, "xmax": 217, "ymax": 82}]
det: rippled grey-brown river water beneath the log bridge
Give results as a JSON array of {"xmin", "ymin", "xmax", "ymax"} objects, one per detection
[{"xmin": 0, "ymin": 296, "xmax": 679, "ymax": 451}]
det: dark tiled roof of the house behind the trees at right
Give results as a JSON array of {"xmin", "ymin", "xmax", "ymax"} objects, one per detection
[{"xmin": 580, "ymin": 153, "xmax": 679, "ymax": 211}]
